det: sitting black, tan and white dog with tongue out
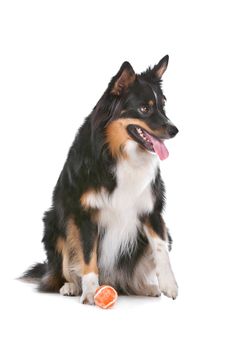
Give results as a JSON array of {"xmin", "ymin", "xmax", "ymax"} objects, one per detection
[{"xmin": 23, "ymin": 56, "xmax": 178, "ymax": 304}]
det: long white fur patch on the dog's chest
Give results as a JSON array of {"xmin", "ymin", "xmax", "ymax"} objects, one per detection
[{"xmin": 86, "ymin": 141, "xmax": 158, "ymax": 273}]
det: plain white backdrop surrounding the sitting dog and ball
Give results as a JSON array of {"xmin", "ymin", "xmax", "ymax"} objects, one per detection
[{"xmin": 0, "ymin": 0, "xmax": 233, "ymax": 350}]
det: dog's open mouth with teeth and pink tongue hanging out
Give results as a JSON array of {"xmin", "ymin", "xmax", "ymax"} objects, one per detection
[{"xmin": 127, "ymin": 124, "xmax": 169, "ymax": 160}]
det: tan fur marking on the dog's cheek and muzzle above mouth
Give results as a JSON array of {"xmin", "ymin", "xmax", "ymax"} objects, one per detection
[{"xmin": 106, "ymin": 118, "xmax": 160, "ymax": 158}]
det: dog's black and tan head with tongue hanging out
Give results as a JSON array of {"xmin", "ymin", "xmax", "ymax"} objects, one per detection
[{"xmin": 92, "ymin": 56, "xmax": 178, "ymax": 159}]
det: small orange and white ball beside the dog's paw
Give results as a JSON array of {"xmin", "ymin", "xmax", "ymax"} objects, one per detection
[{"xmin": 94, "ymin": 285, "xmax": 118, "ymax": 309}]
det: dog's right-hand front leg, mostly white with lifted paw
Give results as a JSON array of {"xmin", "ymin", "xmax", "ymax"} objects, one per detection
[{"xmin": 145, "ymin": 225, "xmax": 178, "ymax": 299}]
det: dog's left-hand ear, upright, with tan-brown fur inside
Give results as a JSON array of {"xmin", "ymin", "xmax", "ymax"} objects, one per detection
[{"xmin": 111, "ymin": 62, "xmax": 136, "ymax": 96}]
